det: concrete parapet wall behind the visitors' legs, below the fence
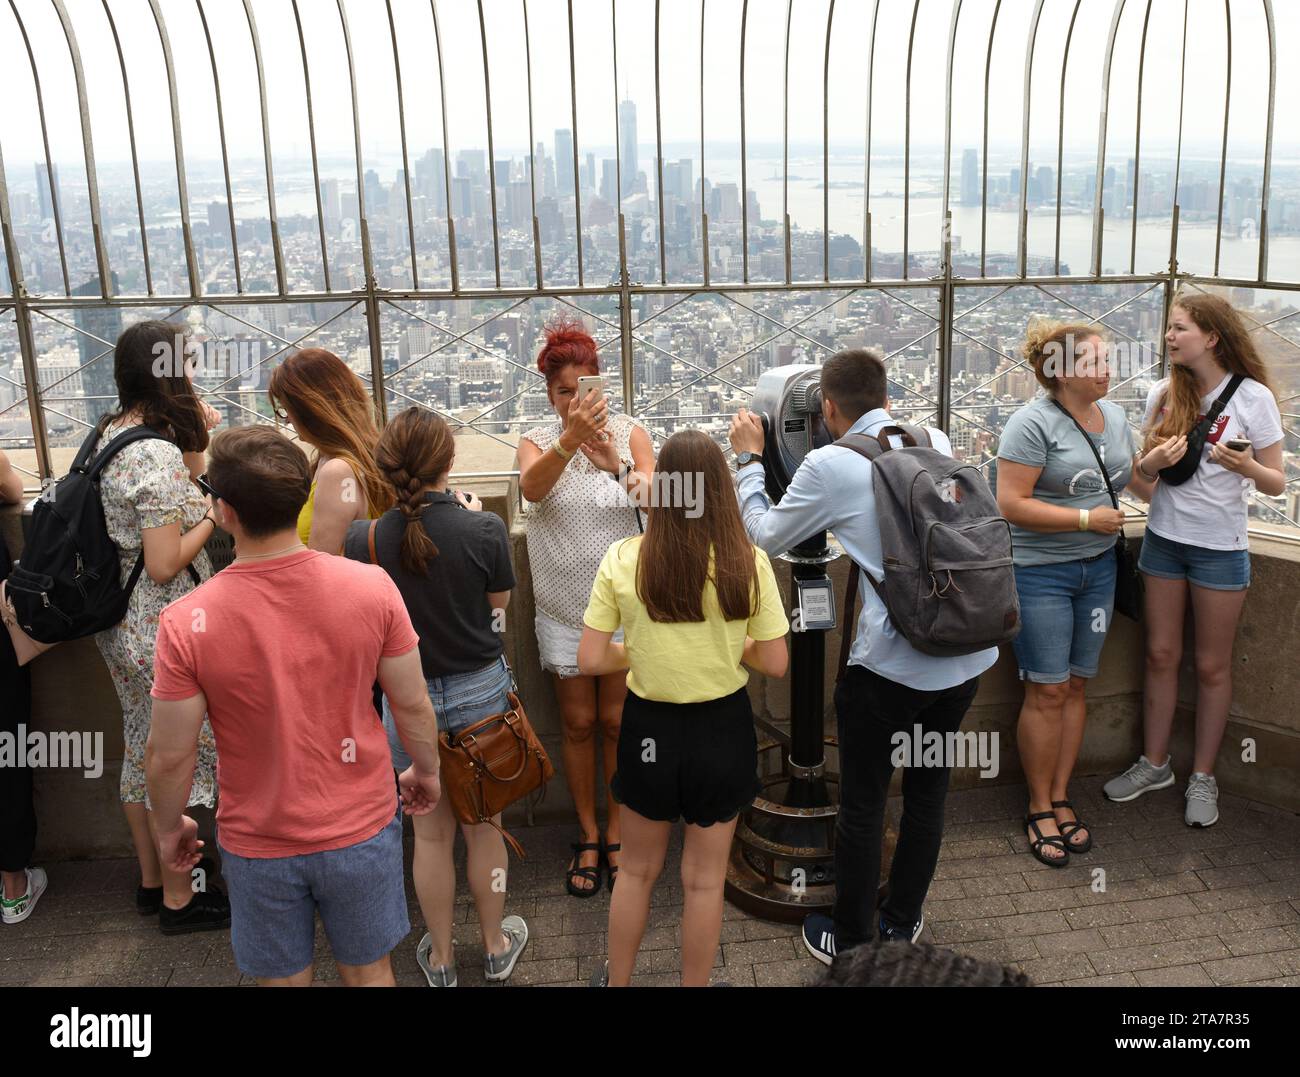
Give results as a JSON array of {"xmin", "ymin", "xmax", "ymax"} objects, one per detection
[{"xmin": 0, "ymin": 499, "xmax": 1300, "ymax": 860}]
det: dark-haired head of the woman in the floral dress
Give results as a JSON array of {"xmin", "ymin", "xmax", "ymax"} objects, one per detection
[{"xmin": 99, "ymin": 321, "xmax": 208, "ymax": 453}]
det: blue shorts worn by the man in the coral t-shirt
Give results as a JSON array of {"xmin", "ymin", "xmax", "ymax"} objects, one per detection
[{"xmin": 221, "ymin": 797, "xmax": 411, "ymax": 979}]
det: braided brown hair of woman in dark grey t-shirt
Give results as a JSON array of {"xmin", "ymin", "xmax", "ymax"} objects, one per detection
[{"xmin": 374, "ymin": 407, "xmax": 456, "ymax": 576}]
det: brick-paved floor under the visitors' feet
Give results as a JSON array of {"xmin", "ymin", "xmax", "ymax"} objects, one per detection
[{"xmin": 0, "ymin": 779, "xmax": 1300, "ymax": 987}]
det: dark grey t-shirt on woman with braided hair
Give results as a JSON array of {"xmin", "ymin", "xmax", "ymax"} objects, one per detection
[{"xmin": 343, "ymin": 492, "xmax": 515, "ymax": 678}]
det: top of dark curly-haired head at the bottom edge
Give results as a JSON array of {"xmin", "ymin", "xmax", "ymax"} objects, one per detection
[{"xmin": 813, "ymin": 939, "xmax": 1034, "ymax": 987}]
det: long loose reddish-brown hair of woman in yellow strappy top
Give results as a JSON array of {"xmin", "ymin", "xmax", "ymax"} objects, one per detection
[{"xmin": 268, "ymin": 347, "xmax": 393, "ymax": 514}]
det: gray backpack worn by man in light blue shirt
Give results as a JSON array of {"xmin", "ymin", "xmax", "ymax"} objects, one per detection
[{"xmin": 835, "ymin": 423, "xmax": 1021, "ymax": 666}]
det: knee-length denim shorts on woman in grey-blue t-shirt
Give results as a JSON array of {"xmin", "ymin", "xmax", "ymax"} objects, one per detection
[{"xmin": 1011, "ymin": 548, "xmax": 1115, "ymax": 684}]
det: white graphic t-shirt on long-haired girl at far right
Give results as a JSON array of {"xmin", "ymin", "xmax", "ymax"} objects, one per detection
[{"xmin": 1143, "ymin": 375, "xmax": 1282, "ymax": 550}]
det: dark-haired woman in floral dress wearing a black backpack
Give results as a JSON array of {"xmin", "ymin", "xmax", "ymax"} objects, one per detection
[{"xmin": 95, "ymin": 321, "xmax": 230, "ymax": 935}]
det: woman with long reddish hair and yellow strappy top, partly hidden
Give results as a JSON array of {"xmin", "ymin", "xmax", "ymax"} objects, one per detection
[{"xmin": 268, "ymin": 347, "xmax": 393, "ymax": 553}]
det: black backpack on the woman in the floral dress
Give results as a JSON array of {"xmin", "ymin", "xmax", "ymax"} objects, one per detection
[{"xmin": 8, "ymin": 427, "xmax": 199, "ymax": 644}]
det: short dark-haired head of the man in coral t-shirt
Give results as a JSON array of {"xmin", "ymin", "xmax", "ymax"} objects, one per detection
[{"xmin": 208, "ymin": 427, "xmax": 312, "ymax": 539}]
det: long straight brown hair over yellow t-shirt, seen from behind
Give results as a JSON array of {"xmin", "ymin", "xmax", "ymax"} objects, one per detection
[{"xmin": 637, "ymin": 431, "xmax": 759, "ymax": 624}]
